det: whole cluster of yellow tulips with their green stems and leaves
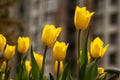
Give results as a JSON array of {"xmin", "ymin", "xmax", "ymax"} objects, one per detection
[{"xmin": 0, "ymin": 6, "xmax": 109, "ymax": 80}]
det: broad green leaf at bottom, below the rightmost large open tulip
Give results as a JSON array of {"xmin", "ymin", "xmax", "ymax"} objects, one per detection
[{"xmin": 85, "ymin": 60, "xmax": 98, "ymax": 80}]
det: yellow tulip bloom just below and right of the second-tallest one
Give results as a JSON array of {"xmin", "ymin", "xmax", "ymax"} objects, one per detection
[{"xmin": 53, "ymin": 41, "xmax": 69, "ymax": 61}]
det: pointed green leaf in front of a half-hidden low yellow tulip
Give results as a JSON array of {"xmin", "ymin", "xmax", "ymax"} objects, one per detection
[{"xmin": 31, "ymin": 46, "xmax": 40, "ymax": 80}]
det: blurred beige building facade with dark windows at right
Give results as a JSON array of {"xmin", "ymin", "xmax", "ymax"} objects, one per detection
[{"xmin": 93, "ymin": 0, "xmax": 120, "ymax": 68}]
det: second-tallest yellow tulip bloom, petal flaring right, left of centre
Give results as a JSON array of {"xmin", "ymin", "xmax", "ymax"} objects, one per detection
[{"xmin": 42, "ymin": 24, "xmax": 62, "ymax": 47}]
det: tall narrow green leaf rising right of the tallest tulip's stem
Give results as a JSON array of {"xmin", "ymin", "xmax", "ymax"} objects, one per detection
[{"xmin": 78, "ymin": 28, "xmax": 90, "ymax": 80}]
